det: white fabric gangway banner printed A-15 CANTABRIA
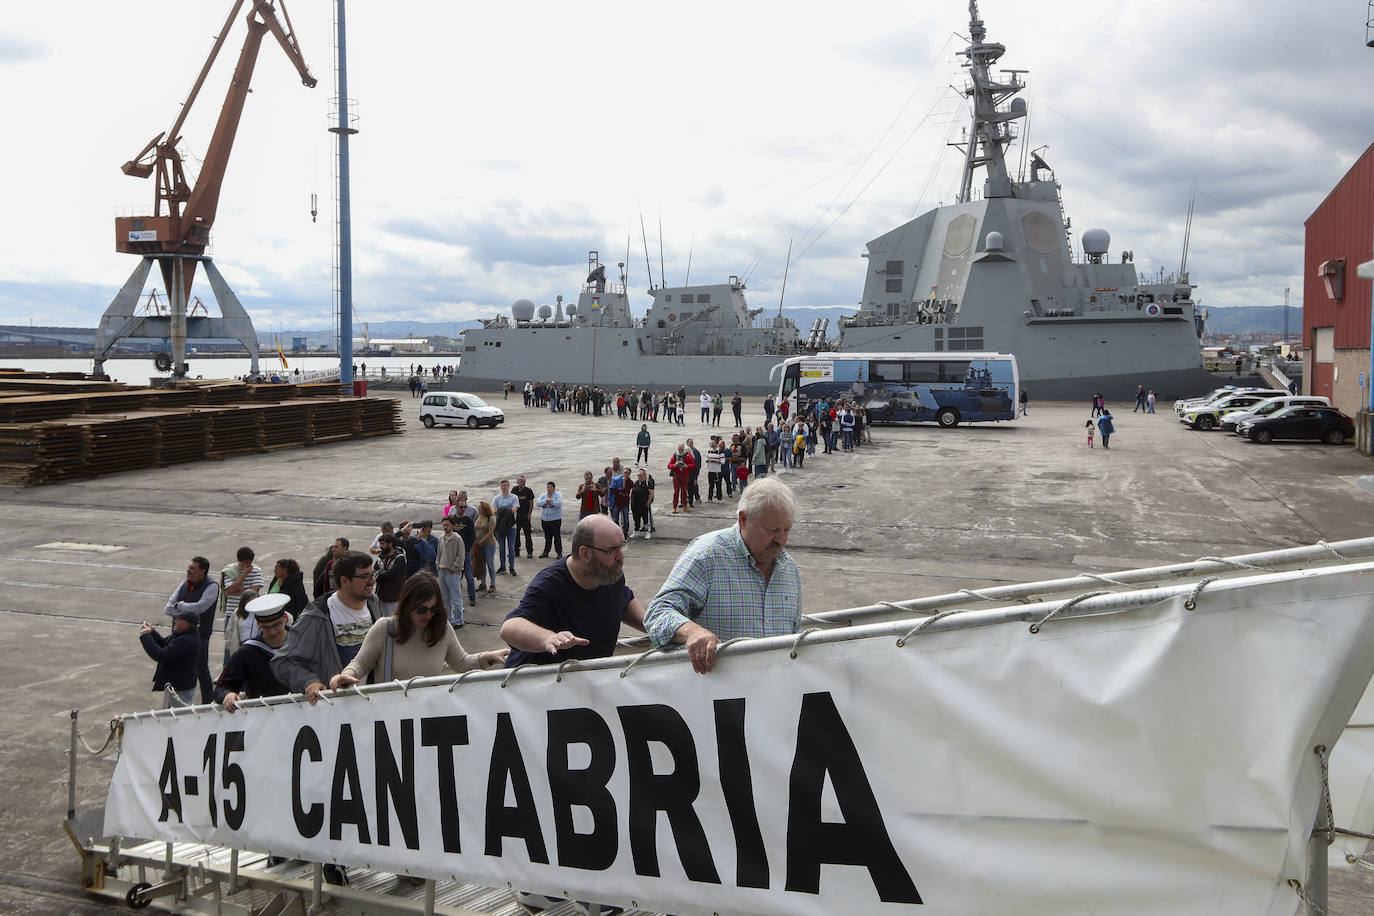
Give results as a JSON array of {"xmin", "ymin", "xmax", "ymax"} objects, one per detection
[{"xmin": 106, "ymin": 564, "xmax": 1374, "ymax": 916}]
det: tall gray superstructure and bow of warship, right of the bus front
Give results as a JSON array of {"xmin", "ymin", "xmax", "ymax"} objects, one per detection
[{"xmin": 838, "ymin": 0, "xmax": 1209, "ymax": 398}]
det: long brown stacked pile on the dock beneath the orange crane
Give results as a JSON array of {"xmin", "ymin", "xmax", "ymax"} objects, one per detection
[{"xmin": 0, "ymin": 372, "xmax": 405, "ymax": 486}]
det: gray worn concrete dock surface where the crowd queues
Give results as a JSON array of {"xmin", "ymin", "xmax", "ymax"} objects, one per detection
[{"xmin": 8, "ymin": 393, "xmax": 1374, "ymax": 916}]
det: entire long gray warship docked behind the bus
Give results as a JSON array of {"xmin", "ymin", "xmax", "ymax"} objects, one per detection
[{"xmin": 458, "ymin": 0, "xmax": 1213, "ymax": 401}]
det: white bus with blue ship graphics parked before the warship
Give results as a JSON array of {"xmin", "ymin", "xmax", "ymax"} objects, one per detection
[{"xmin": 769, "ymin": 352, "xmax": 1021, "ymax": 428}]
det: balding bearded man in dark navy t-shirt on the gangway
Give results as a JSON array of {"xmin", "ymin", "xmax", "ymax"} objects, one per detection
[{"xmin": 502, "ymin": 515, "xmax": 644, "ymax": 667}]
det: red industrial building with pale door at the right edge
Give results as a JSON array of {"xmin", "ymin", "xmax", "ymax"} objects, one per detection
[{"xmin": 1303, "ymin": 144, "xmax": 1374, "ymax": 431}]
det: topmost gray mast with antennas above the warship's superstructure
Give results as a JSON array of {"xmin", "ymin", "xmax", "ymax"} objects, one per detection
[{"xmin": 951, "ymin": 0, "xmax": 1026, "ymax": 203}]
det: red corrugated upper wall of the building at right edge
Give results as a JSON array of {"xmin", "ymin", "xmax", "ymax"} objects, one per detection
[{"xmin": 1303, "ymin": 144, "xmax": 1374, "ymax": 350}]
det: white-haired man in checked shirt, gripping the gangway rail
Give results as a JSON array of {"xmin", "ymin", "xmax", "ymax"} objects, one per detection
[{"xmin": 644, "ymin": 477, "xmax": 801, "ymax": 674}]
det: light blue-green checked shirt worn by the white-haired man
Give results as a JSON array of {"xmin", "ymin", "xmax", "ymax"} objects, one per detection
[{"xmin": 644, "ymin": 525, "xmax": 801, "ymax": 647}]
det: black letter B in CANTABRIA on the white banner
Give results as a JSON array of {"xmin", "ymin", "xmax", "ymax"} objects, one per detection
[{"xmin": 547, "ymin": 707, "xmax": 620, "ymax": 871}]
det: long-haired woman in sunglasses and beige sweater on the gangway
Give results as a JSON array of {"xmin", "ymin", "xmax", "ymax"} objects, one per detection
[{"xmin": 330, "ymin": 571, "xmax": 510, "ymax": 689}]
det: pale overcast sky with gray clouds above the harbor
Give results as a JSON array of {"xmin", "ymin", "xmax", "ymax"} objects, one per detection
[{"xmin": 0, "ymin": 0, "xmax": 1374, "ymax": 334}]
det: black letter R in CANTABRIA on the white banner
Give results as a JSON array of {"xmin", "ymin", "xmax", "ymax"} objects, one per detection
[{"xmin": 616, "ymin": 705, "xmax": 720, "ymax": 884}]
